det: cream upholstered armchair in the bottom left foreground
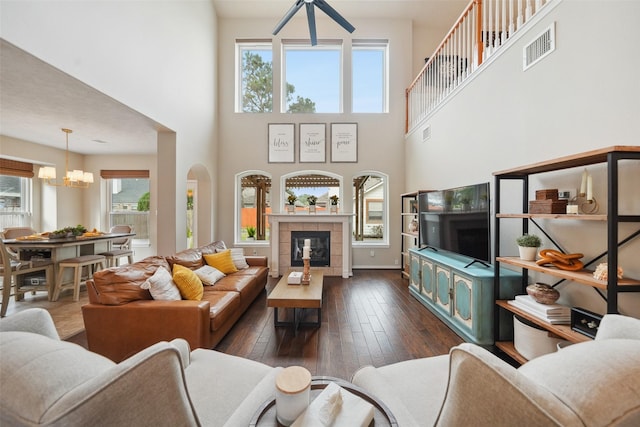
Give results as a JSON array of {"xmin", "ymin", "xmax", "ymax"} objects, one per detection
[{"xmin": 0, "ymin": 309, "xmax": 280, "ymax": 426}]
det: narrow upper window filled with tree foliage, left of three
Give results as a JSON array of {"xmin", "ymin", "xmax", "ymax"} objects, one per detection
[{"xmin": 236, "ymin": 42, "xmax": 273, "ymax": 113}]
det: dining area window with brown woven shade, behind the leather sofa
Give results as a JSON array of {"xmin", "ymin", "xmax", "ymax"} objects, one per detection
[{"xmin": 100, "ymin": 170, "xmax": 151, "ymax": 246}]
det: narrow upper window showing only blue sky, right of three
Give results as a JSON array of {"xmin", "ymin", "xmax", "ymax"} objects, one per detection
[{"xmin": 351, "ymin": 40, "xmax": 388, "ymax": 113}]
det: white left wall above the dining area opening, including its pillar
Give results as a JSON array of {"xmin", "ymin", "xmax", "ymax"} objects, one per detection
[{"xmin": 0, "ymin": 0, "xmax": 217, "ymax": 254}]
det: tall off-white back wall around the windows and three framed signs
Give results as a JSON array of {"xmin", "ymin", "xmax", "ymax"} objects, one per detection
[{"xmin": 218, "ymin": 15, "xmax": 412, "ymax": 267}]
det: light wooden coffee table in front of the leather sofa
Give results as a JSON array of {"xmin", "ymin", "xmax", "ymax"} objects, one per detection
[{"xmin": 267, "ymin": 270, "xmax": 323, "ymax": 333}]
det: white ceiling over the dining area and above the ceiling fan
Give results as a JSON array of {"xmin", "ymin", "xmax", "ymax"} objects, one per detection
[{"xmin": 0, "ymin": 0, "xmax": 468, "ymax": 160}]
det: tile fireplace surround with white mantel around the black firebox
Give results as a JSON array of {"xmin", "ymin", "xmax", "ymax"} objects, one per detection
[{"xmin": 268, "ymin": 213, "xmax": 353, "ymax": 279}]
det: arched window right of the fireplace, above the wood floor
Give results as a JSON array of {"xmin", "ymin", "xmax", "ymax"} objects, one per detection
[{"xmin": 353, "ymin": 171, "xmax": 389, "ymax": 246}]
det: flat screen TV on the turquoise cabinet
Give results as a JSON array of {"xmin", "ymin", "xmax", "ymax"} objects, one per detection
[{"xmin": 418, "ymin": 182, "xmax": 491, "ymax": 262}]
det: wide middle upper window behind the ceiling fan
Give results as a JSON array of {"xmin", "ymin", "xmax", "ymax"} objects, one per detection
[{"xmin": 282, "ymin": 41, "xmax": 342, "ymax": 113}]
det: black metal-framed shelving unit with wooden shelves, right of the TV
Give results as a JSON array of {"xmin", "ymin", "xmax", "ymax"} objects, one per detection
[{"xmin": 493, "ymin": 146, "xmax": 640, "ymax": 363}]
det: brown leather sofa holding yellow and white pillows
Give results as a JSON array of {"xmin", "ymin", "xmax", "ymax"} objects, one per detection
[{"xmin": 82, "ymin": 241, "xmax": 269, "ymax": 362}]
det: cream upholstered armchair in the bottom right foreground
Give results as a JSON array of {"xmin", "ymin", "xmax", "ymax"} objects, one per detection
[{"xmin": 352, "ymin": 314, "xmax": 640, "ymax": 427}]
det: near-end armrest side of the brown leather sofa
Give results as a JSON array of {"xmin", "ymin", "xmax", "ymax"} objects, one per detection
[{"xmin": 82, "ymin": 300, "xmax": 210, "ymax": 362}]
